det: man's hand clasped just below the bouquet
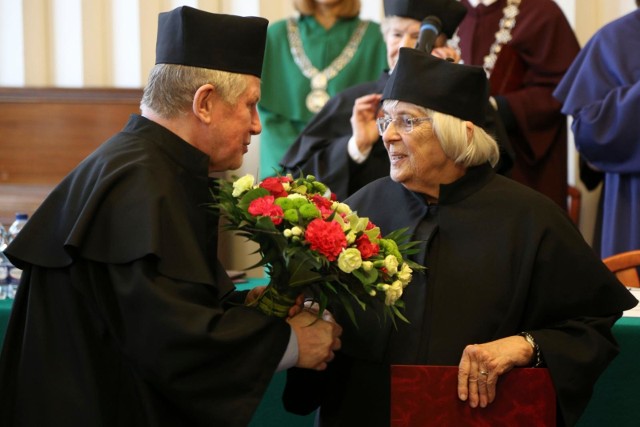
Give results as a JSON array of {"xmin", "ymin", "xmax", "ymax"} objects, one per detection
[{"xmin": 287, "ymin": 310, "xmax": 342, "ymax": 371}]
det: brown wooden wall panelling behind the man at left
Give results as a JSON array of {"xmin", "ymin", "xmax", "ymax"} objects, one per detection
[{"xmin": 0, "ymin": 88, "xmax": 142, "ymax": 226}]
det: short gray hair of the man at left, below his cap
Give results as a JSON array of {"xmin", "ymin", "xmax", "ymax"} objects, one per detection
[{"xmin": 140, "ymin": 64, "xmax": 247, "ymax": 119}]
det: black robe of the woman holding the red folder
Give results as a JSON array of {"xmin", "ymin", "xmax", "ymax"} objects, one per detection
[{"xmin": 284, "ymin": 165, "xmax": 637, "ymax": 426}]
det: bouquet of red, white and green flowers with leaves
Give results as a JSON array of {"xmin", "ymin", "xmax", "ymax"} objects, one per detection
[{"xmin": 213, "ymin": 174, "xmax": 424, "ymax": 324}]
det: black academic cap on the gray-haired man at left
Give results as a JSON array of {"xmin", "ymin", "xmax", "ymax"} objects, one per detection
[{"xmin": 156, "ymin": 6, "xmax": 269, "ymax": 77}]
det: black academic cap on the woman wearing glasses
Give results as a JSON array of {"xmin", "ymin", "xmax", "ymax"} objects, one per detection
[{"xmin": 382, "ymin": 47, "xmax": 489, "ymax": 127}]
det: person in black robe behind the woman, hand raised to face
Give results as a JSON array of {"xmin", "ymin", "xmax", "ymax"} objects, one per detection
[{"xmin": 281, "ymin": 0, "xmax": 511, "ymax": 200}]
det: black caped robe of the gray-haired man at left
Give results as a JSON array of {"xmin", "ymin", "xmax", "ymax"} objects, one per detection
[{"xmin": 0, "ymin": 116, "xmax": 290, "ymax": 427}]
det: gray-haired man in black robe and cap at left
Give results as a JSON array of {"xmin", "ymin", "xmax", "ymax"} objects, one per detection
[{"xmin": 0, "ymin": 6, "xmax": 340, "ymax": 427}]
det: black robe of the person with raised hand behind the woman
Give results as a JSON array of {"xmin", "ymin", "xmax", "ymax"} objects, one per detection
[{"xmin": 280, "ymin": 72, "xmax": 513, "ymax": 200}]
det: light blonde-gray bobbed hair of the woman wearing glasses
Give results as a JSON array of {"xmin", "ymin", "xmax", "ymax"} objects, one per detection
[{"xmin": 383, "ymin": 100, "xmax": 500, "ymax": 167}]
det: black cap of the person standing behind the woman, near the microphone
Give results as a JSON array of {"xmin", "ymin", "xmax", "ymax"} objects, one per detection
[{"xmin": 384, "ymin": 0, "xmax": 467, "ymax": 38}]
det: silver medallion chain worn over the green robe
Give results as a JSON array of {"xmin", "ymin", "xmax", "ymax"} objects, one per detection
[{"xmin": 287, "ymin": 18, "xmax": 369, "ymax": 113}]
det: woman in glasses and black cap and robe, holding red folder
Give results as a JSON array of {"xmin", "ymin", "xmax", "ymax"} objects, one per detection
[{"xmin": 283, "ymin": 48, "xmax": 638, "ymax": 427}]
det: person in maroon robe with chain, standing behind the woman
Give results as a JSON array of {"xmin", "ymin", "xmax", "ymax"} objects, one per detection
[{"xmin": 452, "ymin": 0, "xmax": 580, "ymax": 209}]
